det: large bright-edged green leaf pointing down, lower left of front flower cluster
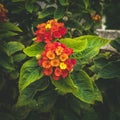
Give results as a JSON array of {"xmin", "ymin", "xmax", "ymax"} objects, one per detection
[{"xmin": 19, "ymin": 59, "xmax": 43, "ymax": 92}]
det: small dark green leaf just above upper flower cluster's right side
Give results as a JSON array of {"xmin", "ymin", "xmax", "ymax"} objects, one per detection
[{"xmin": 54, "ymin": 6, "xmax": 66, "ymax": 20}]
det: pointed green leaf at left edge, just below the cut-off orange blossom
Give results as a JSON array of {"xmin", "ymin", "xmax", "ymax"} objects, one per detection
[{"xmin": 0, "ymin": 22, "xmax": 22, "ymax": 32}]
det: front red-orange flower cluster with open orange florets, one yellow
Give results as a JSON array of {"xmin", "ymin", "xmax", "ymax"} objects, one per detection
[{"xmin": 38, "ymin": 42, "xmax": 76, "ymax": 80}]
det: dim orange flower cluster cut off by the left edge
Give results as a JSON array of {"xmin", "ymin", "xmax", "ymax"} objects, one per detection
[{"xmin": 0, "ymin": 4, "xmax": 7, "ymax": 22}]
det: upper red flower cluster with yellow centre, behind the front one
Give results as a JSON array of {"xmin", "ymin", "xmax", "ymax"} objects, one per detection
[{"xmin": 34, "ymin": 19, "xmax": 67, "ymax": 43}]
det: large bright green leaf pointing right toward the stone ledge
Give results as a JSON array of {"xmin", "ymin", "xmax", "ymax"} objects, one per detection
[{"xmin": 72, "ymin": 35, "xmax": 110, "ymax": 64}]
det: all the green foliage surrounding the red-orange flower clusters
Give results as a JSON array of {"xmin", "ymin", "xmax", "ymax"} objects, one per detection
[{"xmin": 0, "ymin": 0, "xmax": 120, "ymax": 120}]
